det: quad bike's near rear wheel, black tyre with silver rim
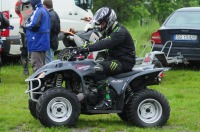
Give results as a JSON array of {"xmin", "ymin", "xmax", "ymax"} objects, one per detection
[{"xmin": 127, "ymin": 89, "xmax": 170, "ymax": 127}]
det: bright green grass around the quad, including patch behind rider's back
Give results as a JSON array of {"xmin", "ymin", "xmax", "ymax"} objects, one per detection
[{"xmin": 0, "ymin": 22, "xmax": 200, "ymax": 132}]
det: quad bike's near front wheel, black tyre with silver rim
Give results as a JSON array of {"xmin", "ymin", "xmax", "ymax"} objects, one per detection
[{"xmin": 36, "ymin": 88, "xmax": 81, "ymax": 127}]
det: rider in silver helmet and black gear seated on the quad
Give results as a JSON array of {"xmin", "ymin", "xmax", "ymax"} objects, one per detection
[{"xmin": 79, "ymin": 7, "xmax": 135, "ymax": 109}]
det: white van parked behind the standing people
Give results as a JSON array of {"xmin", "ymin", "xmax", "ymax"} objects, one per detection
[{"xmin": 0, "ymin": 0, "xmax": 93, "ymax": 56}]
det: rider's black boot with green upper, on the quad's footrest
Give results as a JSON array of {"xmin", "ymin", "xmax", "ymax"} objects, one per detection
[{"xmin": 94, "ymin": 83, "xmax": 112, "ymax": 110}]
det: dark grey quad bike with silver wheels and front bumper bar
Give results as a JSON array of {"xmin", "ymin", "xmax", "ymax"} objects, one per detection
[{"xmin": 25, "ymin": 48, "xmax": 170, "ymax": 127}]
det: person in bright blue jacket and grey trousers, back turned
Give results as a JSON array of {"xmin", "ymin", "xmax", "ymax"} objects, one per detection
[{"xmin": 26, "ymin": 0, "xmax": 51, "ymax": 72}]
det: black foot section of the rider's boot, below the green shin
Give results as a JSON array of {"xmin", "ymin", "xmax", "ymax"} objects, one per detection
[{"xmin": 94, "ymin": 99, "xmax": 112, "ymax": 110}]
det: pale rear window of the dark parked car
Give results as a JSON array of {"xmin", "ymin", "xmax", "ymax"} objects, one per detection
[{"xmin": 165, "ymin": 12, "xmax": 200, "ymax": 28}]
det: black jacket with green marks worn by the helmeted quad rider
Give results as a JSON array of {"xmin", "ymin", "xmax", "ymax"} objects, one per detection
[{"xmin": 88, "ymin": 23, "xmax": 135, "ymax": 66}]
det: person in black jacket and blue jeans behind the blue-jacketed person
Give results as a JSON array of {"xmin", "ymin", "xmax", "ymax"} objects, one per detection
[{"xmin": 43, "ymin": 0, "xmax": 60, "ymax": 64}]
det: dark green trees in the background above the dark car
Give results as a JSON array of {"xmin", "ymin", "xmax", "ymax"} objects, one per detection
[{"xmin": 93, "ymin": 0, "xmax": 200, "ymax": 24}]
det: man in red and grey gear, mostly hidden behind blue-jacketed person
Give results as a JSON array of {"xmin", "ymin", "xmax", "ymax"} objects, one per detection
[{"xmin": 15, "ymin": 0, "xmax": 32, "ymax": 75}]
